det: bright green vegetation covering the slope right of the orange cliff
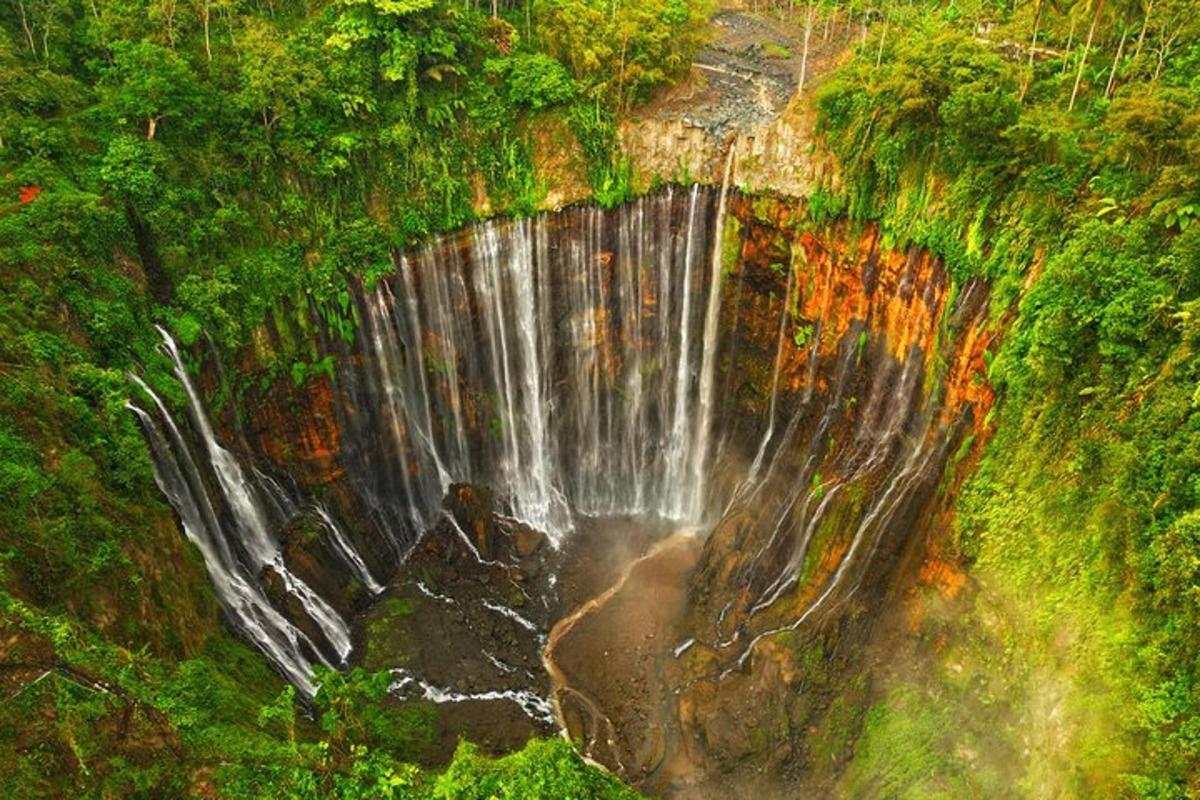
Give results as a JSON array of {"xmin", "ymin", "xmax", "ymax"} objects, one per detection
[{"xmin": 814, "ymin": 2, "xmax": 1200, "ymax": 798}]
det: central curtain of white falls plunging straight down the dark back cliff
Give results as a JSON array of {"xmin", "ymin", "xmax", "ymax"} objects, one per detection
[{"xmin": 340, "ymin": 185, "xmax": 725, "ymax": 543}]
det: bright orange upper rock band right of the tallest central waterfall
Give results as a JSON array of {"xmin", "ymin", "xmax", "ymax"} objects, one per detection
[{"xmin": 732, "ymin": 197, "xmax": 996, "ymax": 433}]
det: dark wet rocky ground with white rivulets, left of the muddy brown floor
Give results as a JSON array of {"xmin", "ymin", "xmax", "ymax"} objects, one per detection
[{"xmin": 358, "ymin": 483, "xmax": 557, "ymax": 758}]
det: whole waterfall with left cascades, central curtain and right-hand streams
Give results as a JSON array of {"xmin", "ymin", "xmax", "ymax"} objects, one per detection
[{"xmin": 130, "ymin": 184, "xmax": 985, "ymax": 692}]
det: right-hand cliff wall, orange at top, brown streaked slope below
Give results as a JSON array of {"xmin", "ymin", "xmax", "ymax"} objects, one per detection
[{"xmin": 667, "ymin": 196, "xmax": 995, "ymax": 796}]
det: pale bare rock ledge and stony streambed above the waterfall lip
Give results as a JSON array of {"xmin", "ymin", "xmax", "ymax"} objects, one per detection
[{"xmin": 535, "ymin": 8, "xmax": 844, "ymax": 215}]
